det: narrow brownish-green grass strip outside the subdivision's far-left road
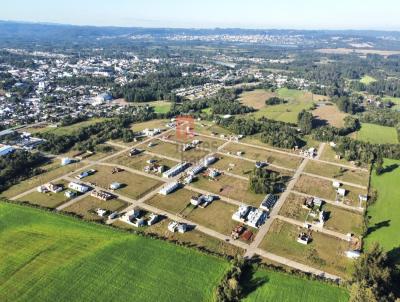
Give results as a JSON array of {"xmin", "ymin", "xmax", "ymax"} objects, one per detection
[{"xmin": 0, "ymin": 159, "xmax": 84, "ymax": 198}]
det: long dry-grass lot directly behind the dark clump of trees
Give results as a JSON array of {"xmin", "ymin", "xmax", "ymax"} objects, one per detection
[{"xmin": 222, "ymin": 143, "xmax": 301, "ymax": 169}]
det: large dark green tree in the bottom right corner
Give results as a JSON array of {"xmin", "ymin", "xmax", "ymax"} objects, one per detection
[{"xmin": 350, "ymin": 243, "xmax": 395, "ymax": 302}]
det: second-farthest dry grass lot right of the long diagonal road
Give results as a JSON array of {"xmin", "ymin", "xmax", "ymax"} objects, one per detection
[{"xmin": 304, "ymin": 160, "xmax": 369, "ymax": 186}]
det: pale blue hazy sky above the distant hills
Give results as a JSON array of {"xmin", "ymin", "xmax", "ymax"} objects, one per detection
[{"xmin": 0, "ymin": 0, "xmax": 400, "ymax": 30}]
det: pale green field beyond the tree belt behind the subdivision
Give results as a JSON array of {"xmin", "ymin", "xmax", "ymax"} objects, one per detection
[{"xmin": 252, "ymin": 88, "xmax": 326, "ymax": 124}]
